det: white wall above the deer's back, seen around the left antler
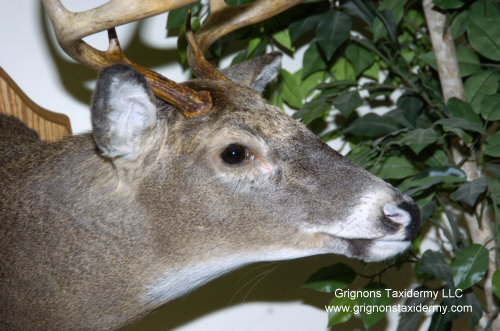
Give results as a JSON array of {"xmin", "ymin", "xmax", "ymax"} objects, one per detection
[{"xmin": 0, "ymin": 0, "xmax": 189, "ymax": 133}]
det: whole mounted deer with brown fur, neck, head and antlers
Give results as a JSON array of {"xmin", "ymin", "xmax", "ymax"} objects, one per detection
[{"xmin": 0, "ymin": 0, "xmax": 420, "ymax": 330}]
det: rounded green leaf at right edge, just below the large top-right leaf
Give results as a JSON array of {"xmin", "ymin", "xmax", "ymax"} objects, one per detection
[{"xmin": 464, "ymin": 70, "xmax": 499, "ymax": 114}]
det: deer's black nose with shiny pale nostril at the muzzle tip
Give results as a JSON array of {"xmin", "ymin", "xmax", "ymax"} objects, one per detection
[{"xmin": 383, "ymin": 201, "xmax": 420, "ymax": 240}]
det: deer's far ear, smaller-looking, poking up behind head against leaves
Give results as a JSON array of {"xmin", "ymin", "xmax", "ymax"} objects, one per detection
[{"xmin": 221, "ymin": 52, "xmax": 283, "ymax": 92}]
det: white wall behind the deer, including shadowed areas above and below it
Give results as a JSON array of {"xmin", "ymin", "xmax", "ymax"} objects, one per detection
[{"xmin": 0, "ymin": 0, "xmax": 422, "ymax": 331}]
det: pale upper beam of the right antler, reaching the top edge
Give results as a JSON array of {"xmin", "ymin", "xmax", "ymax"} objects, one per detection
[{"xmin": 196, "ymin": 0, "xmax": 304, "ymax": 53}]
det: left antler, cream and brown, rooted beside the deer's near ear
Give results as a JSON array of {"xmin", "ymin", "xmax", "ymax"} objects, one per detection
[{"xmin": 42, "ymin": 0, "xmax": 212, "ymax": 117}]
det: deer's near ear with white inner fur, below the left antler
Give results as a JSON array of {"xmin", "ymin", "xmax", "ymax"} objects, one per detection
[{"xmin": 91, "ymin": 64, "xmax": 157, "ymax": 159}]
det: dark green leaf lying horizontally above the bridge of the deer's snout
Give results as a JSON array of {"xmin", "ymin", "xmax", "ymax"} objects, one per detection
[{"xmin": 344, "ymin": 113, "xmax": 400, "ymax": 137}]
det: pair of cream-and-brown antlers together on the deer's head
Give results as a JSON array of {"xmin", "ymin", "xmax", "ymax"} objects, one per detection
[{"xmin": 42, "ymin": 0, "xmax": 304, "ymax": 117}]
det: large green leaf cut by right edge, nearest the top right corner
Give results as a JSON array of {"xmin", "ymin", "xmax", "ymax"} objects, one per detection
[{"xmin": 467, "ymin": 13, "xmax": 500, "ymax": 61}]
